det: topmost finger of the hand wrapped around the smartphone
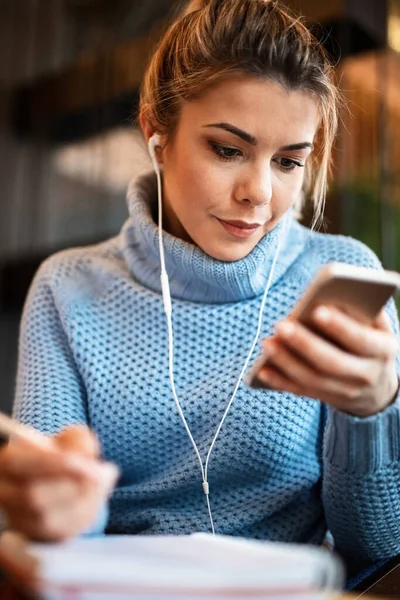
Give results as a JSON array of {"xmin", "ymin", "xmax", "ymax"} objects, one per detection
[{"xmin": 312, "ymin": 306, "xmax": 398, "ymax": 359}]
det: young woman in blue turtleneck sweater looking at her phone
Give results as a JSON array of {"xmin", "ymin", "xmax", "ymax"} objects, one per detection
[{"xmin": 0, "ymin": 0, "xmax": 400, "ymax": 563}]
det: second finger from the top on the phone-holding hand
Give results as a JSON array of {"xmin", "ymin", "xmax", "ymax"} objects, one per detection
[{"xmin": 276, "ymin": 320, "xmax": 376, "ymax": 384}]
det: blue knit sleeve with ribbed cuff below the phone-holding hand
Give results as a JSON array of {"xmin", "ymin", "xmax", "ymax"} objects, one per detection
[{"xmin": 323, "ymin": 292, "xmax": 400, "ymax": 566}]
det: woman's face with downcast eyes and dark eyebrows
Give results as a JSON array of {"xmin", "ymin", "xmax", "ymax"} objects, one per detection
[{"xmin": 156, "ymin": 76, "xmax": 318, "ymax": 261}]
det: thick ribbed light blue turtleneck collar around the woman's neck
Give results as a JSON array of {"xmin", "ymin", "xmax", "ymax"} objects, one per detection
[{"xmin": 121, "ymin": 173, "xmax": 306, "ymax": 304}]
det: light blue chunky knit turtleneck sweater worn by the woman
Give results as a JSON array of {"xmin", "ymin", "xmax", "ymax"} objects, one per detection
[{"xmin": 15, "ymin": 175, "xmax": 400, "ymax": 561}]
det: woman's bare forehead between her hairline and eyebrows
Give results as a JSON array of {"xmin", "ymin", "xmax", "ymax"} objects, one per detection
[{"xmin": 179, "ymin": 76, "xmax": 319, "ymax": 146}]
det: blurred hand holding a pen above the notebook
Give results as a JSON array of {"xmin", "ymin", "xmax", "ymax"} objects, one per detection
[{"xmin": 0, "ymin": 426, "xmax": 118, "ymax": 541}]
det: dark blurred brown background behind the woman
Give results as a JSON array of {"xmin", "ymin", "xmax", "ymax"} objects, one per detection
[{"xmin": 0, "ymin": 0, "xmax": 400, "ymax": 412}]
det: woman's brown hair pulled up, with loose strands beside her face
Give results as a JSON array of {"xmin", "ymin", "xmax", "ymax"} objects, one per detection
[{"xmin": 140, "ymin": 0, "xmax": 340, "ymax": 226}]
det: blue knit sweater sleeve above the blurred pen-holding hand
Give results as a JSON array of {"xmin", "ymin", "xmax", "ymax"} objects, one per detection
[{"xmin": 13, "ymin": 259, "xmax": 107, "ymax": 534}]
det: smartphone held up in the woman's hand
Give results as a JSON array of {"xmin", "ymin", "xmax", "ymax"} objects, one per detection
[{"xmin": 246, "ymin": 263, "xmax": 400, "ymax": 388}]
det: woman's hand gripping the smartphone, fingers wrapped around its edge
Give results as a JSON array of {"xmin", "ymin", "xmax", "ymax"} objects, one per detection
[{"xmin": 258, "ymin": 306, "xmax": 399, "ymax": 417}]
